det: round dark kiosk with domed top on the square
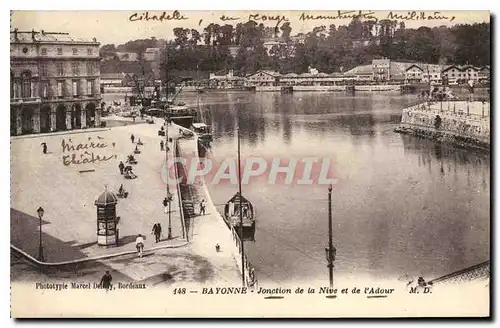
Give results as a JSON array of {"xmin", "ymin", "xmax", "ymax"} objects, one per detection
[{"xmin": 95, "ymin": 189, "xmax": 118, "ymax": 246}]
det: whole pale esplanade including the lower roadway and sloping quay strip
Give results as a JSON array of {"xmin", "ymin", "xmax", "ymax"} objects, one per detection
[{"xmin": 11, "ymin": 119, "xmax": 240, "ymax": 283}]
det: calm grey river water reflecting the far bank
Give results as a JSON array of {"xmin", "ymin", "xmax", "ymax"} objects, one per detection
[{"xmin": 104, "ymin": 92, "xmax": 490, "ymax": 283}]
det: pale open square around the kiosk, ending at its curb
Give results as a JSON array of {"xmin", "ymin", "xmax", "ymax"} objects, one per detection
[{"xmin": 10, "ymin": 120, "xmax": 185, "ymax": 262}]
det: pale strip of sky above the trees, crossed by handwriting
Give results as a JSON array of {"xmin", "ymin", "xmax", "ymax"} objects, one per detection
[{"xmin": 11, "ymin": 10, "xmax": 490, "ymax": 44}]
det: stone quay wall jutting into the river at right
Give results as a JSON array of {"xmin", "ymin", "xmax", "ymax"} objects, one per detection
[{"xmin": 395, "ymin": 104, "xmax": 490, "ymax": 151}]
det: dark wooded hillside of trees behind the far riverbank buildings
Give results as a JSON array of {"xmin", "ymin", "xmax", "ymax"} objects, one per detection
[{"xmin": 100, "ymin": 18, "xmax": 490, "ymax": 80}]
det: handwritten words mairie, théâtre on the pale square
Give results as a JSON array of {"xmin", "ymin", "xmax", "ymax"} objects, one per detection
[{"xmin": 61, "ymin": 137, "xmax": 116, "ymax": 166}]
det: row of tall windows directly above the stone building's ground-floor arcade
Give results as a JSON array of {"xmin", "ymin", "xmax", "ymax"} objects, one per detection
[{"xmin": 10, "ymin": 79, "xmax": 96, "ymax": 99}]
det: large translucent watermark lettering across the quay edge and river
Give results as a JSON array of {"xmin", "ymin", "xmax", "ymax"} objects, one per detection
[{"xmin": 161, "ymin": 155, "xmax": 338, "ymax": 186}]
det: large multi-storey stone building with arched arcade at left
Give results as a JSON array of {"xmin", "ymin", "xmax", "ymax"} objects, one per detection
[{"xmin": 10, "ymin": 29, "xmax": 102, "ymax": 135}]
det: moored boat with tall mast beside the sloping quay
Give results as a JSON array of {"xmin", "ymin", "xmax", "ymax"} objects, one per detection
[{"xmin": 224, "ymin": 192, "xmax": 255, "ymax": 241}]
